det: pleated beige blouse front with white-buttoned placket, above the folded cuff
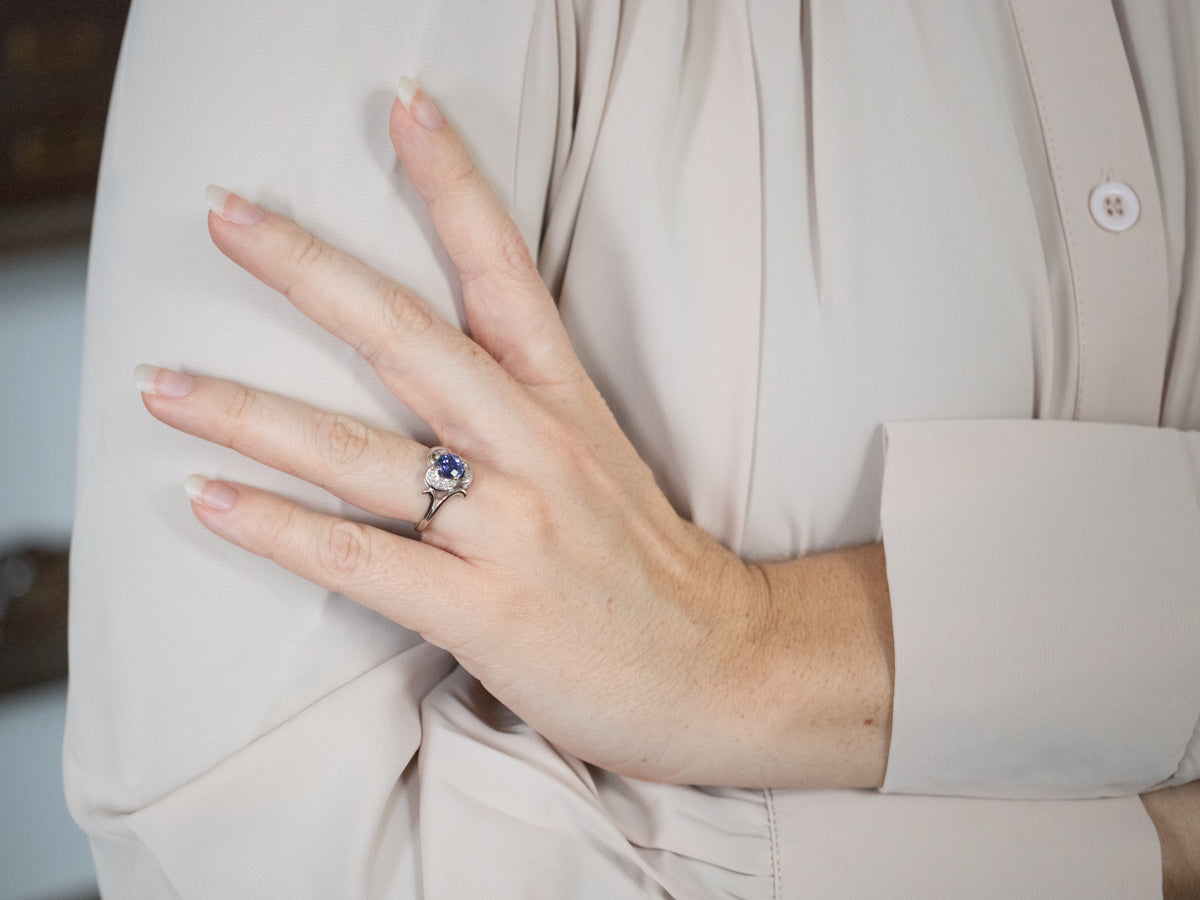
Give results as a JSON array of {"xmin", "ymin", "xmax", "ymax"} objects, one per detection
[{"xmin": 552, "ymin": 2, "xmax": 1190, "ymax": 551}]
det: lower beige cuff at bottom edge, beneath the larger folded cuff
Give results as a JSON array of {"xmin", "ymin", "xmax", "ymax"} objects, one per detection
[{"xmin": 773, "ymin": 791, "xmax": 1163, "ymax": 900}]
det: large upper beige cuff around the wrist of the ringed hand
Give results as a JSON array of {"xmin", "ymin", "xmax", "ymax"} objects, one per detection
[{"xmin": 881, "ymin": 421, "xmax": 1200, "ymax": 798}]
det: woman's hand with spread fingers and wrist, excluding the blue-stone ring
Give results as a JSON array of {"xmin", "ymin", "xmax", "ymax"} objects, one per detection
[{"xmin": 139, "ymin": 79, "xmax": 890, "ymax": 786}]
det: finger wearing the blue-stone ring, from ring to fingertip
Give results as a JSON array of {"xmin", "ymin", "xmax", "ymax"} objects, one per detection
[{"xmin": 137, "ymin": 365, "xmax": 440, "ymax": 522}]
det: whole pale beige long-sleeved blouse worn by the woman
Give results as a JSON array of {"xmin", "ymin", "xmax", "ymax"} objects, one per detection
[{"xmin": 64, "ymin": 0, "xmax": 1200, "ymax": 899}]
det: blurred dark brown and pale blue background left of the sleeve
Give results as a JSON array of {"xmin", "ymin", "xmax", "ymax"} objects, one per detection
[{"xmin": 0, "ymin": 0, "xmax": 128, "ymax": 900}]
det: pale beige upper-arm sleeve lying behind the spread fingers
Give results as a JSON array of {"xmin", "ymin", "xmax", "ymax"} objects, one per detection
[{"xmin": 64, "ymin": 0, "xmax": 558, "ymax": 898}]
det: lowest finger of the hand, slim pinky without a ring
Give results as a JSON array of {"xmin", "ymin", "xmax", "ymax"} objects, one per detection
[{"xmin": 185, "ymin": 475, "xmax": 470, "ymax": 646}]
